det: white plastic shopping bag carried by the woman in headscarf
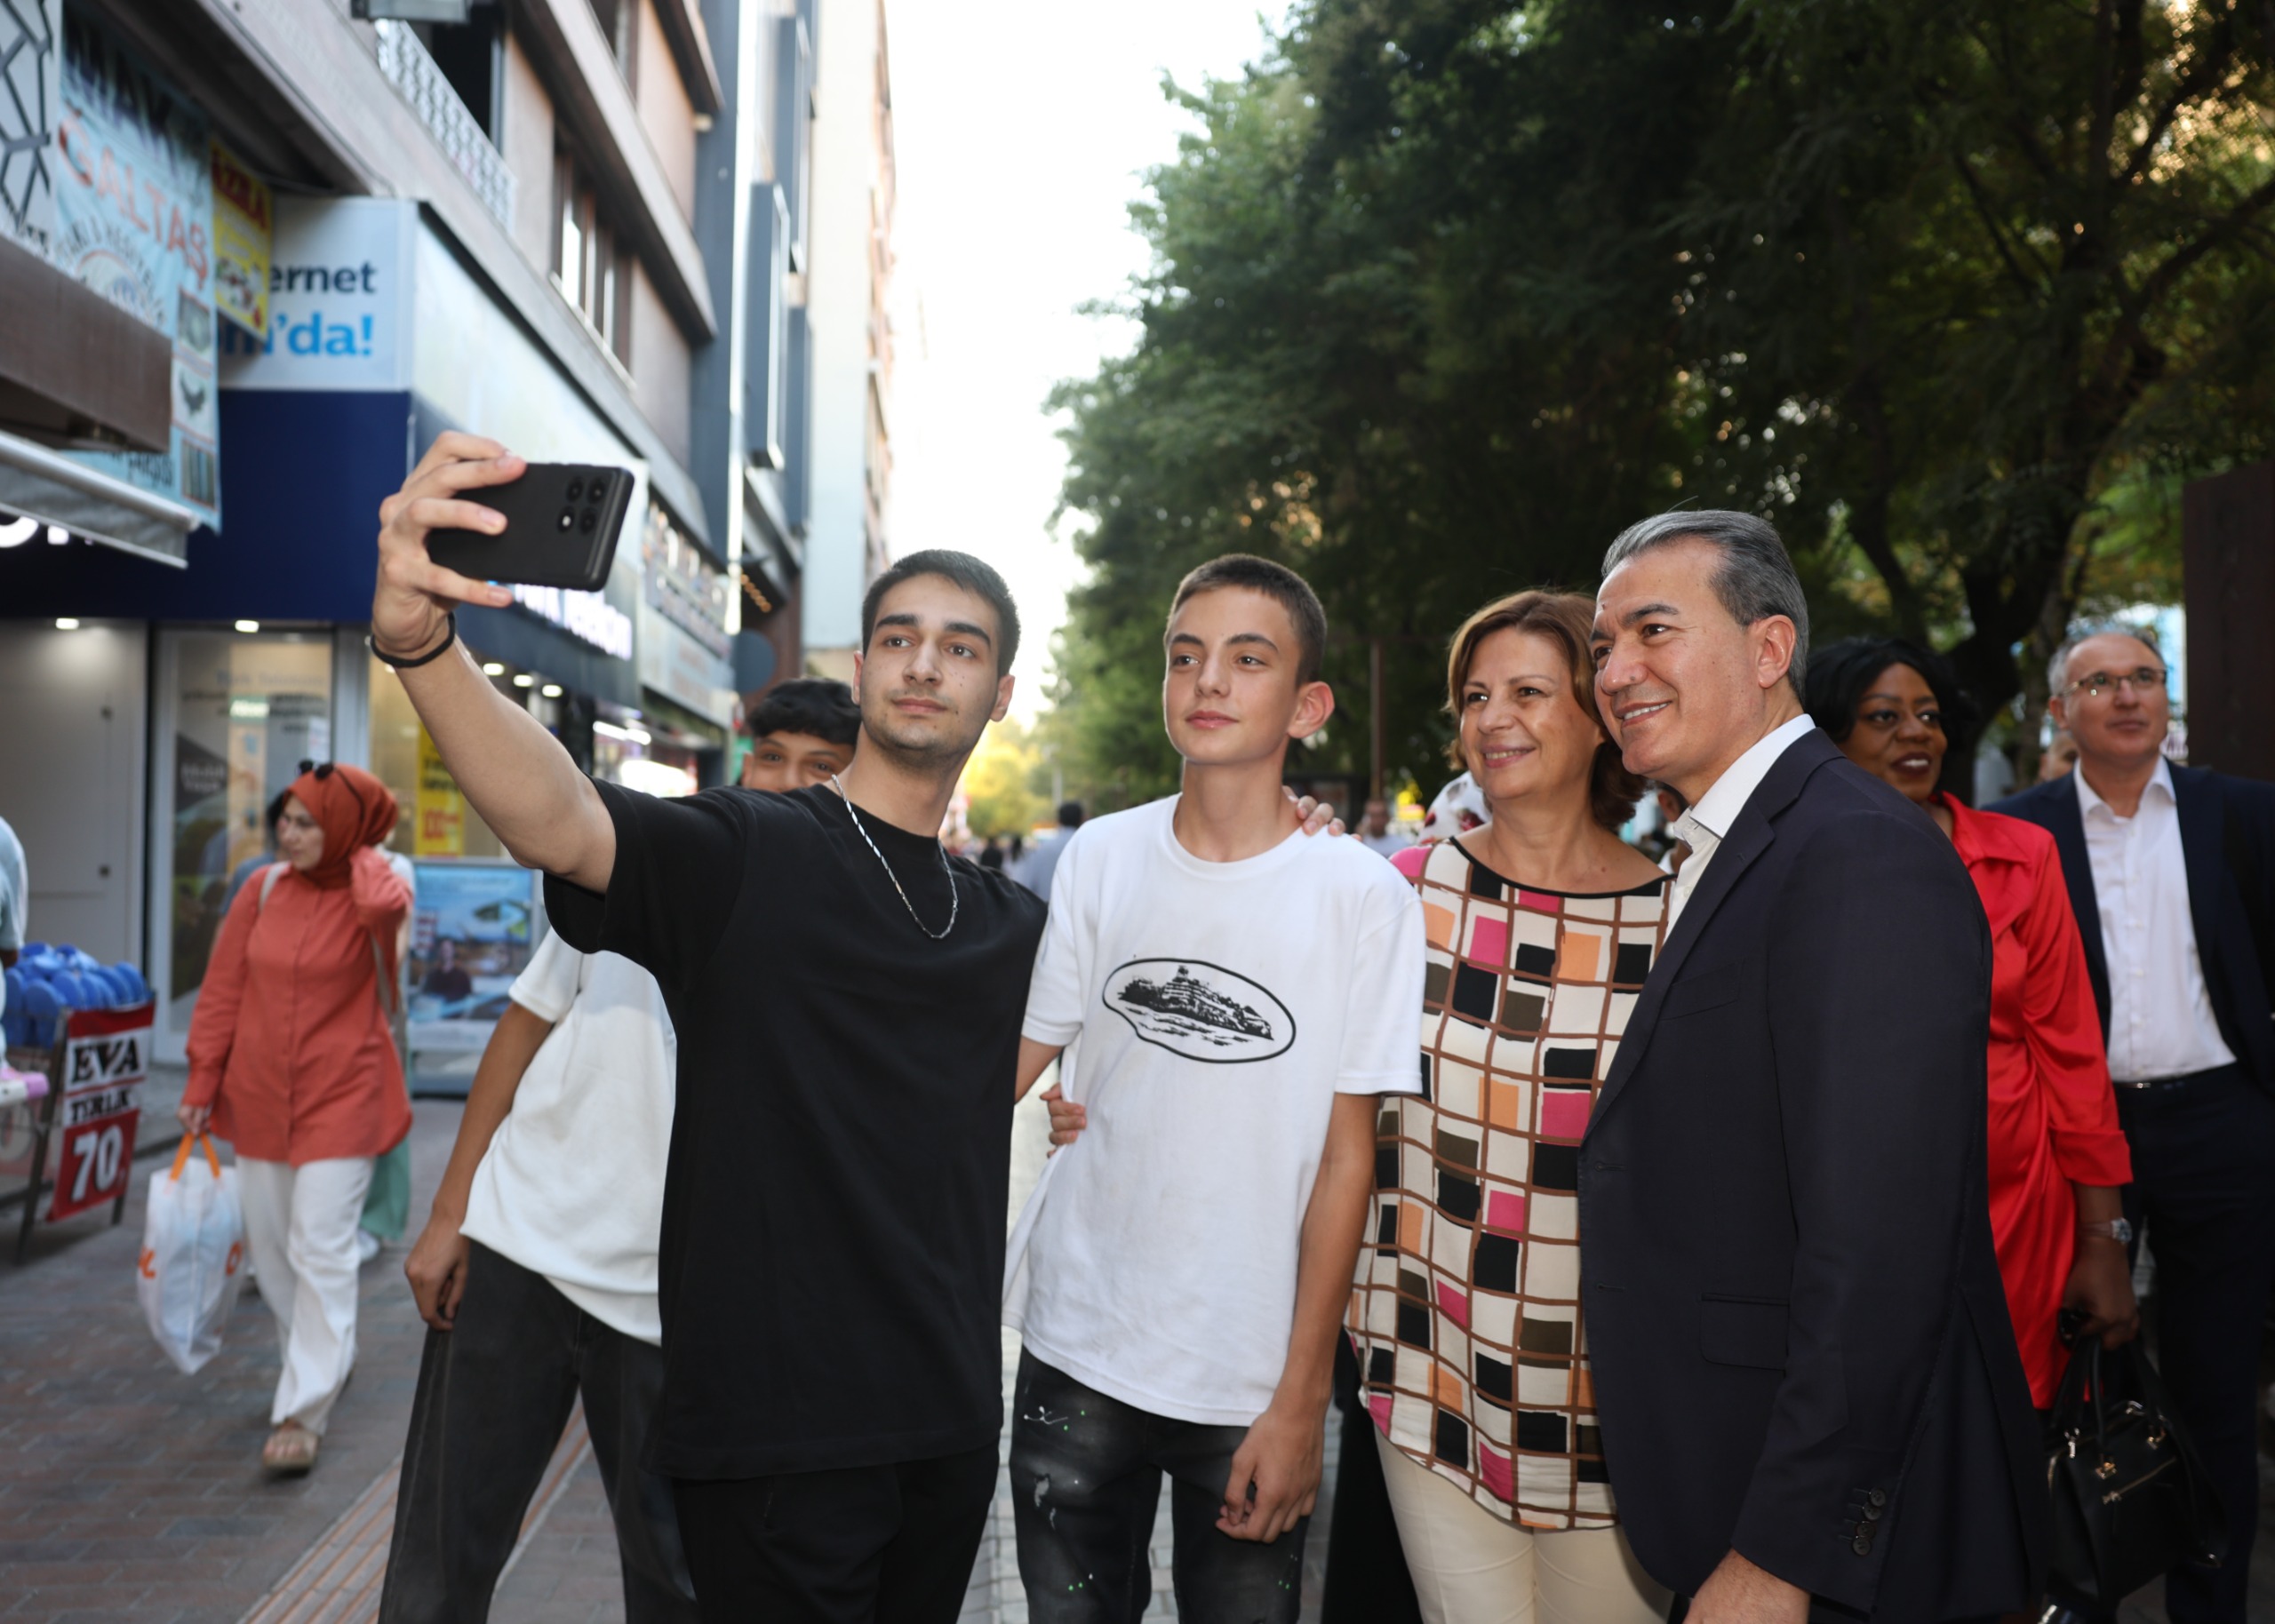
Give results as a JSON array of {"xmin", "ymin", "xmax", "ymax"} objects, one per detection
[{"xmin": 134, "ymin": 1133, "xmax": 245, "ymax": 1376}]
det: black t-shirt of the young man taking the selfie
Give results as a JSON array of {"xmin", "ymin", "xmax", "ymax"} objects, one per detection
[{"xmin": 546, "ymin": 783, "xmax": 1044, "ymax": 1478}]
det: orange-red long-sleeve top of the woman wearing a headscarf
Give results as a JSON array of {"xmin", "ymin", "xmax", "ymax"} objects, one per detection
[{"xmin": 182, "ymin": 846, "xmax": 411, "ymax": 1166}]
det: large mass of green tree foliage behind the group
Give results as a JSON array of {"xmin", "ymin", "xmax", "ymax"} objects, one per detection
[{"xmin": 1053, "ymin": 0, "xmax": 2275, "ymax": 800}]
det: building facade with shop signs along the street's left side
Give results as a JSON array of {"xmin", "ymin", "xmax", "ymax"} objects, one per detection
[{"xmin": 0, "ymin": 0, "xmax": 882, "ymax": 1058}]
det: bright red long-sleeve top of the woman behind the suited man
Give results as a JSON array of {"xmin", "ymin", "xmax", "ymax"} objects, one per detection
[{"xmin": 1943, "ymin": 796, "xmax": 2132, "ymax": 1410}]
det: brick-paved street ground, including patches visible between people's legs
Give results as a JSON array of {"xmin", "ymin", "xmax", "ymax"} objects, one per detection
[{"xmin": 0, "ymin": 1073, "xmax": 2275, "ymax": 1624}]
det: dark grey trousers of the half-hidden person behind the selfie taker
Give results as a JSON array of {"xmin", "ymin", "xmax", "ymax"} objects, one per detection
[{"xmin": 380, "ymin": 1242, "xmax": 698, "ymax": 1624}]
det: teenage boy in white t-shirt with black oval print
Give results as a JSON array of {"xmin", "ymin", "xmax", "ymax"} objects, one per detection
[{"xmin": 1006, "ymin": 555, "xmax": 1422, "ymax": 1624}]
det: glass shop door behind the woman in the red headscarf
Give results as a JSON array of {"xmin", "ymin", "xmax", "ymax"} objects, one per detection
[{"xmin": 150, "ymin": 628, "xmax": 336, "ymax": 1063}]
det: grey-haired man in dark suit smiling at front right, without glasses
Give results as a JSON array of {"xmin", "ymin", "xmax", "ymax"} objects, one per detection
[{"xmin": 1579, "ymin": 512, "xmax": 2045, "ymax": 1624}]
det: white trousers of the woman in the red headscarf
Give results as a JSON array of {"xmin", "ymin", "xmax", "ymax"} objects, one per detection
[{"xmin": 236, "ymin": 1156, "xmax": 373, "ymax": 1436}]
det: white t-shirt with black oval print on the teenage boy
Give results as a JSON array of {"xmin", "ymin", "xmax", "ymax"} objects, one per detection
[{"xmin": 1003, "ymin": 799, "xmax": 1422, "ymax": 1426}]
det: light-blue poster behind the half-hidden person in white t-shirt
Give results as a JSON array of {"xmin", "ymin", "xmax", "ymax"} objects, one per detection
[{"xmin": 405, "ymin": 857, "xmax": 544, "ymax": 1055}]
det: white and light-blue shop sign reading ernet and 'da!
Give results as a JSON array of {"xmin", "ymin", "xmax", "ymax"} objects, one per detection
[{"xmin": 220, "ymin": 198, "xmax": 419, "ymax": 391}]
